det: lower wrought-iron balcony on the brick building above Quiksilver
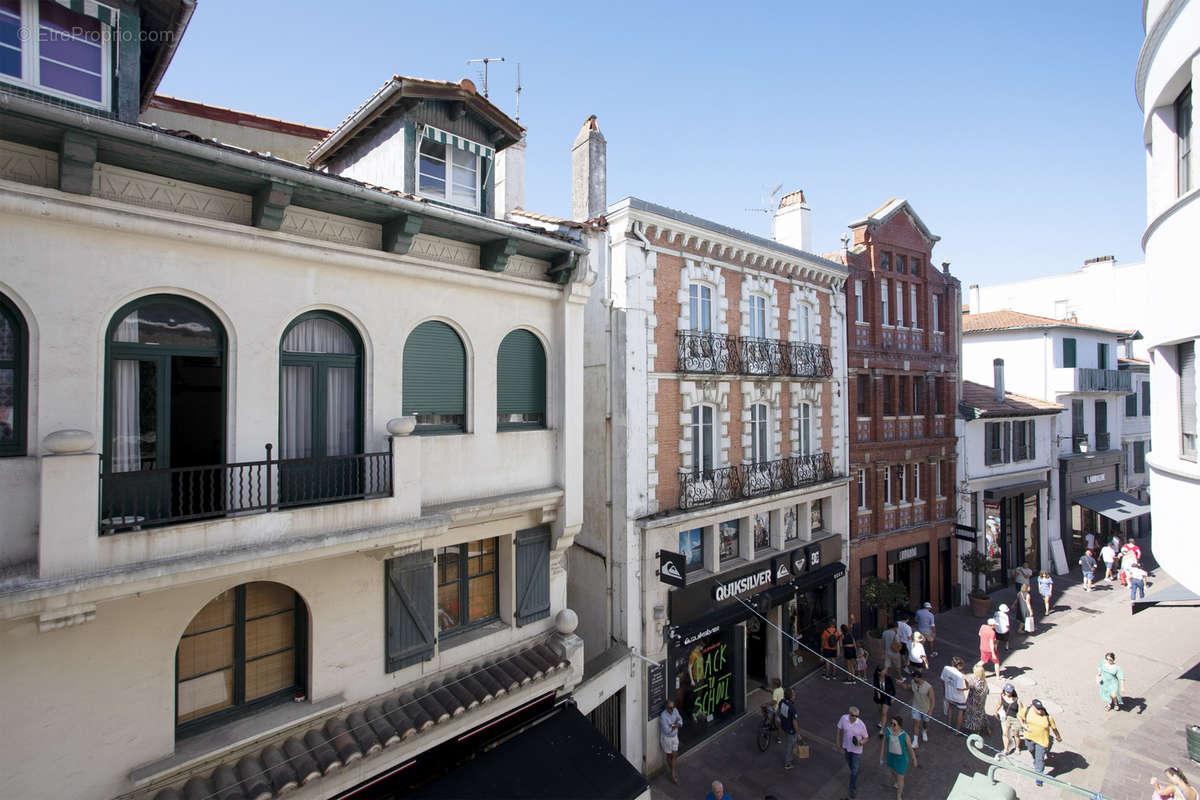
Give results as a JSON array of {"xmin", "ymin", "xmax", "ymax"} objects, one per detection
[{"xmin": 679, "ymin": 453, "xmax": 834, "ymax": 511}]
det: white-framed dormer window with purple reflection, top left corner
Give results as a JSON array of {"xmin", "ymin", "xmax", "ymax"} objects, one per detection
[{"xmin": 0, "ymin": 0, "xmax": 116, "ymax": 109}]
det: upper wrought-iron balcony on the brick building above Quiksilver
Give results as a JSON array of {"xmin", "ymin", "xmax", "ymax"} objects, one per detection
[{"xmin": 676, "ymin": 331, "xmax": 833, "ymax": 378}]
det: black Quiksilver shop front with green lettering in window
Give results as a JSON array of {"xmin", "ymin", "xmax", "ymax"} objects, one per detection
[{"xmin": 666, "ymin": 536, "xmax": 846, "ymax": 750}]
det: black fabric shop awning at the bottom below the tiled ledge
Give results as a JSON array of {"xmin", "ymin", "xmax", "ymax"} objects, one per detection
[{"xmin": 406, "ymin": 705, "xmax": 649, "ymax": 800}]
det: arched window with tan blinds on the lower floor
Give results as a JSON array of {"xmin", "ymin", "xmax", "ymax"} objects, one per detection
[{"xmin": 175, "ymin": 581, "xmax": 307, "ymax": 733}]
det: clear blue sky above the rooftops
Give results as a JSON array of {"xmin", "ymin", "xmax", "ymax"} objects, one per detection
[{"xmin": 154, "ymin": 0, "xmax": 1146, "ymax": 284}]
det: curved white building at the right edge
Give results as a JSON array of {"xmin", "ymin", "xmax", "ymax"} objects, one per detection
[{"xmin": 1136, "ymin": 0, "xmax": 1200, "ymax": 591}]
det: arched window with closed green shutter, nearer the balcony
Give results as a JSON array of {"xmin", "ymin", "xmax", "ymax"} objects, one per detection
[{"xmin": 403, "ymin": 320, "xmax": 467, "ymax": 433}]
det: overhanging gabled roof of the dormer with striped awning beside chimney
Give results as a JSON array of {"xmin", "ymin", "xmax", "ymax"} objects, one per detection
[{"xmin": 307, "ymin": 76, "xmax": 524, "ymax": 167}]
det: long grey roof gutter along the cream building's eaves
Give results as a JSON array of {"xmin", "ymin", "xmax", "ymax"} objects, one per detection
[{"xmin": 0, "ymin": 91, "xmax": 588, "ymax": 254}]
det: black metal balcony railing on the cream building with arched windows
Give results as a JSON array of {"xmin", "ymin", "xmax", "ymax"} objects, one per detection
[{"xmin": 100, "ymin": 440, "xmax": 392, "ymax": 535}]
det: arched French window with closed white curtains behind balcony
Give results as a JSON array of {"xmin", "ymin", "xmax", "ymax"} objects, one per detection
[{"xmin": 280, "ymin": 311, "xmax": 362, "ymax": 458}]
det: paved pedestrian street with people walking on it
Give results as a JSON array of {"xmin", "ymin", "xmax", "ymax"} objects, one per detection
[{"xmin": 652, "ymin": 556, "xmax": 1200, "ymax": 800}]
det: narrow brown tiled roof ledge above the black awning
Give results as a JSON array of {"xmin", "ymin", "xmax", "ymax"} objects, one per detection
[{"xmin": 154, "ymin": 643, "xmax": 569, "ymax": 800}]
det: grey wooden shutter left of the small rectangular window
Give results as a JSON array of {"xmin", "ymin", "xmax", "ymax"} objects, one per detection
[{"xmin": 384, "ymin": 551, "xmax": 437, "ymax": 672}]
